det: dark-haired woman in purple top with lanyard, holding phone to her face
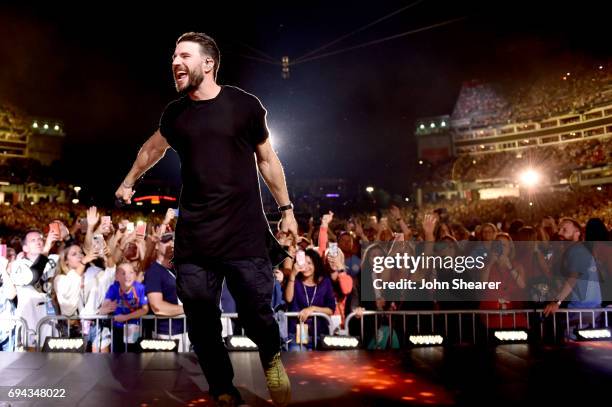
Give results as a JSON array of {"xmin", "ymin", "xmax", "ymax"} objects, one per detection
[{"xmin": 285, "ymin": 249, "xmax": 336, "ymax": 350}]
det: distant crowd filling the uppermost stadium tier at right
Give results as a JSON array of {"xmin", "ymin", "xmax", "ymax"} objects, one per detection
[{"xmin": 452, "ymin": 63, "xmax": 612, "ymax": 127}]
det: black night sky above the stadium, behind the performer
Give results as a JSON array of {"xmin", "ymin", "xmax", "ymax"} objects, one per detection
[{"xmin": 0, "ymin": 0, "xmax": 612, "ymax": 204}]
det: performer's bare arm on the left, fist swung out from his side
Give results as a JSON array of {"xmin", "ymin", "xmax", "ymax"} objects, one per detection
[{"xmin": 115, "ymin": 130, "xmax": 170, "ymax": 204}]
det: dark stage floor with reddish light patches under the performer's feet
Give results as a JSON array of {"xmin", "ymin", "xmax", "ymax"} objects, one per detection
[{"xmin": 0, "ymin": 342, "xmax": 612, "ymax": 407}]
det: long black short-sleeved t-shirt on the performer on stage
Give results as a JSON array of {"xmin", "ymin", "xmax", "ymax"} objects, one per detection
[{"xmin": 159, "ymin": 86, "xmax": 268, "ymax": 264}]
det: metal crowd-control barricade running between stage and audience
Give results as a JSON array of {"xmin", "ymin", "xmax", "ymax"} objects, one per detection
[{"xmin": 31, "ymin": 308, "xmax": 612, "ymax": 352}]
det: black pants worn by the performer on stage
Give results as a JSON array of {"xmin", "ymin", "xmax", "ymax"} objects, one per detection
[{"xmin": 176, "ymin": 257, "xmax": 281, "ymax": 397}]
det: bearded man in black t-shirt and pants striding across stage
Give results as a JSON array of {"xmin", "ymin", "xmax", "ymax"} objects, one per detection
[{"xmin": 115, "ymin": 32, "xmax": 297, "ymax": 406}]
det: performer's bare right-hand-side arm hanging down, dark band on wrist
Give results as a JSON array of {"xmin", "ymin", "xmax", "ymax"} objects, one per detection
[{"xmin": 255, "ymin": 138, "xmax": 297, "ymax": 241}]
